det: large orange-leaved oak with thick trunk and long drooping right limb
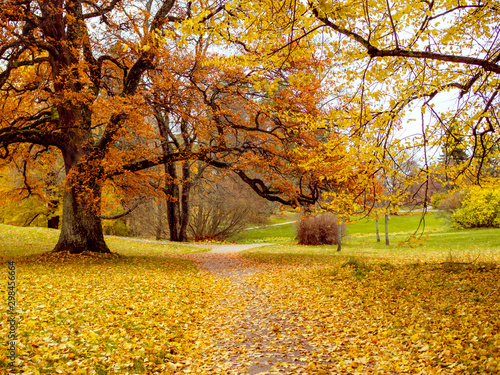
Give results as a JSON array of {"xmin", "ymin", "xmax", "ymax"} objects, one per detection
[{"xmin": 0, "ymin": 0, "xmax": 340, "ymax": 253}]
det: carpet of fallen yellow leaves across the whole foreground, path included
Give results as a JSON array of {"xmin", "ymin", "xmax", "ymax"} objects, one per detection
[{"xmin": 0, "ymin": 236, "xmax": 500, "ymax": 375}]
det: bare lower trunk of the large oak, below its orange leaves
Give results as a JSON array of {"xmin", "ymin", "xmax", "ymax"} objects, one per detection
[{"xmin": 53, "ymin": 184, "xmax": 110, "ymax": 254}]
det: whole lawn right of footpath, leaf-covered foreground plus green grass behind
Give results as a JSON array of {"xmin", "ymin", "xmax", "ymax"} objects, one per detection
[{"xmin": 236, "ymin": 213, "xmax": 500, "ymax": 374}]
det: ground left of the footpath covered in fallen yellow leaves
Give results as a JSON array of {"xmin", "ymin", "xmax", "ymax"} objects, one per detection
[{"xmin": 0, "ymin": 256, "xmax": 217, "ymax": 374}]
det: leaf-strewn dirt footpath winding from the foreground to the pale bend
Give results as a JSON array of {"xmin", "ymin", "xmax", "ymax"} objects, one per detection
[{"xmin": 174, "ymin": 245, "xmax": 331, "ymax": 375}]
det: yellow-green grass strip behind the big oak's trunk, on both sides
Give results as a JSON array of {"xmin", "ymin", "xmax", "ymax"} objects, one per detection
[{"xmin": 0, "ymin": 224, "xmax": 207, "ymax": 257}]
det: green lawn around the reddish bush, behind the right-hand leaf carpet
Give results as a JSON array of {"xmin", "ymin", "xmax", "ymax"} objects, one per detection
[{"xmin": 238, "ymin": 212, "xmax": 500, "ymax": 263}]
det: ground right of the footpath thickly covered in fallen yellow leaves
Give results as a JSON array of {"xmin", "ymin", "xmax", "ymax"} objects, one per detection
[{"xmin": 237, "ymin": 254, "xmax": 500, "ymax": 374}]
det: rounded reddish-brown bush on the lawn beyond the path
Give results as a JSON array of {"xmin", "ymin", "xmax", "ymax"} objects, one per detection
[{"xmin": 297, "ymin": 214, "xmax": 345, "ymax": 245}]
